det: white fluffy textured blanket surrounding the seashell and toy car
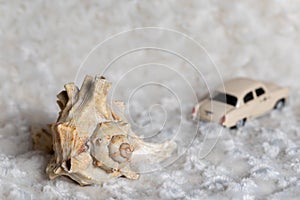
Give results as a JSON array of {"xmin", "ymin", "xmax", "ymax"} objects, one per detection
[{"xmin": 0, "ymin": 0, "xmax": 300, "ymax": 199}]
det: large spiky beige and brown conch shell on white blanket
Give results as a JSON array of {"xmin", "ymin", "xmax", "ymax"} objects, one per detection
[{"xmin": 33, "ymin": 76, "xmax": 176, "ymax": 185}]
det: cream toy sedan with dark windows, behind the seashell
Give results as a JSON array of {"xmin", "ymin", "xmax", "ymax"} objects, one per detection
[{"xmin": 192, "ymin": 78, "xmax": 289, "ymax": 128}]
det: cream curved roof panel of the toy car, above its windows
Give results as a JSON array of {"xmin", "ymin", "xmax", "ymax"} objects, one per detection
[{"xmin": 218, "ymin": 78, "xmax": 262, "ymax": 98}]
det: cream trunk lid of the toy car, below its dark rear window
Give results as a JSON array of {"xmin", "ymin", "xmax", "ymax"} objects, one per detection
[{"xmin": 200, "ymin": 99, "xmax": 235, "ymax": 123}]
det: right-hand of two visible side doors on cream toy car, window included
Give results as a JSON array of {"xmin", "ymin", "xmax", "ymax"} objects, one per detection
[{"xmin": 254, "ymin": 87, "xmax": 270, "ymax": 116}]
